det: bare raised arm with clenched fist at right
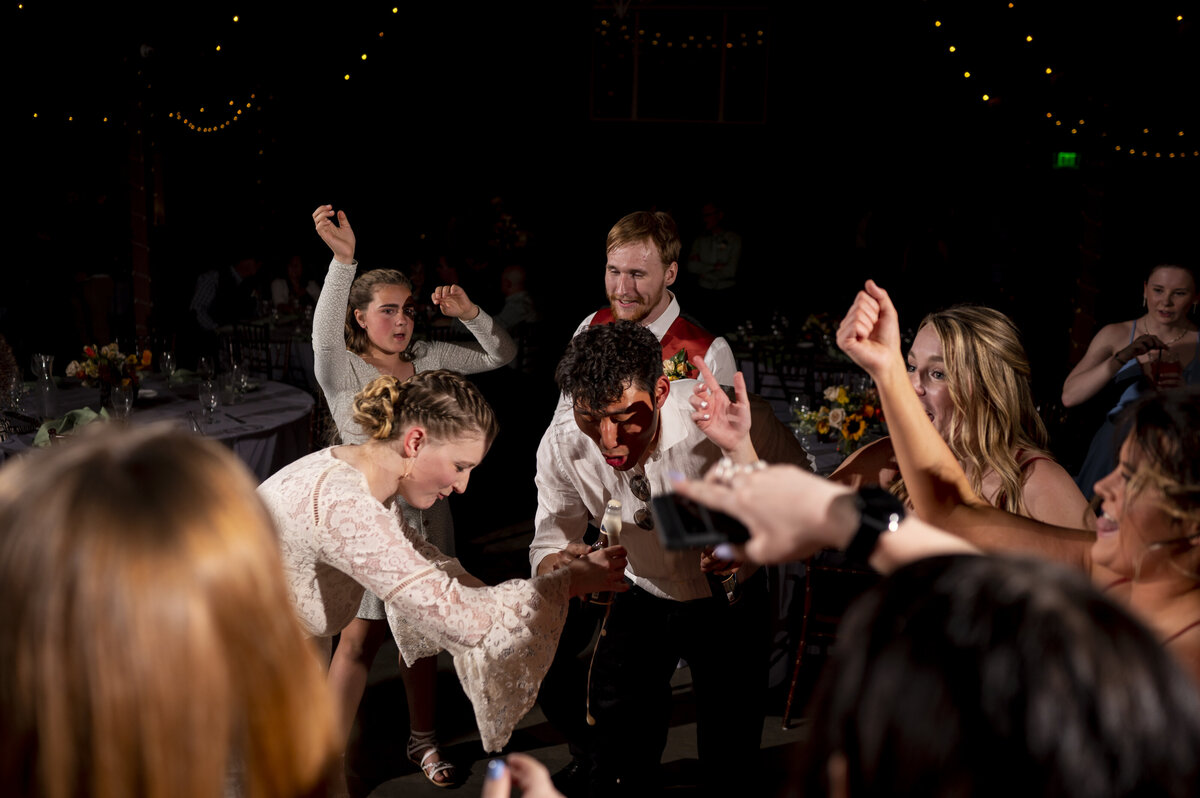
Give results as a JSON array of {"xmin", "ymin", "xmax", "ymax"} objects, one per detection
[{"xmin": 838, "ymin": 281, "xmax": 1092, "ymax": 568}]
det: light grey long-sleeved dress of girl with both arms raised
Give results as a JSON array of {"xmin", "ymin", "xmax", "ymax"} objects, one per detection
[{"xmin": 312, "ymin": 258, "xmax": 517, "ymax": 624}]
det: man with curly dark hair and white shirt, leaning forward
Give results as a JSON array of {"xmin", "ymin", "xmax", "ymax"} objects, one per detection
[{"xmin": 529, "ymin": 320, "xmax": 767, "ymax": 796}]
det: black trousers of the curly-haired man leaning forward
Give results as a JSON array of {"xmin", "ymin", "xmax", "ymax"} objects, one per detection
[{"xmin": 590, "ymin": 572, "xmax": 769, "ymax": 797}]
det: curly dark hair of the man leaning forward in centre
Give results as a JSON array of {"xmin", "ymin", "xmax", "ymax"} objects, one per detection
[{"xmin": 554, "ymin": 322, "xmax": 662, "ymax": 409}]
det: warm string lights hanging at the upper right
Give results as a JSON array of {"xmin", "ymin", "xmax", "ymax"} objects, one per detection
[{"xmin": 930, "ymin": 0, "xmax": 1200, "ymax": 161}]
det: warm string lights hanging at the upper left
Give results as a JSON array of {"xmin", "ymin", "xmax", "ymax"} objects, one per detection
[{"xmin": 18, "ymin": 4, "xmax": 400, "ymax": 134}]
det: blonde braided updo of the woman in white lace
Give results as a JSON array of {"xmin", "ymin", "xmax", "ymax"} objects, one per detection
[{"xmin": 354, "ymin": 368, "xmax": 500, "ymax": 446}]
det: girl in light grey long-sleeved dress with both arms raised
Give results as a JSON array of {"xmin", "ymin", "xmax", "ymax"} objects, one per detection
[{"xmin": 312, "ymin": 200, "xmax": 516, "ymax": 786}]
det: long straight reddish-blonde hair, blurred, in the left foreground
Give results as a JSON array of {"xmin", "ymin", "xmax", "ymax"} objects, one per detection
[{"xmin": 0, "ymin": 425, "xmax": 337, "ymax": 798}]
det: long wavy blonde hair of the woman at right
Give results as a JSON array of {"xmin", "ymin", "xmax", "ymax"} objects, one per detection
[{"xmin": 893, "ymin": 305, "xmax": 1050, "ymax": 515}]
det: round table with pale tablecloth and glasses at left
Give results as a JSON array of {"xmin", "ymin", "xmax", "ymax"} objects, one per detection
[{"xmin": 0, "ymin": 376, "xmax": 313, "ymax": 481}]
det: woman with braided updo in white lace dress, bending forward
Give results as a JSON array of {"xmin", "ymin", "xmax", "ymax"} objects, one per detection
[{"xmin": 258, "ymin": 371, "xmax": 625, "ymax": 751}]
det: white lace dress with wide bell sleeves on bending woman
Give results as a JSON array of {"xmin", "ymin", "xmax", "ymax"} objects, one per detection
[{"xmin": 258, "ymin": 449, "xmax": 570, "ymax": 751}]
